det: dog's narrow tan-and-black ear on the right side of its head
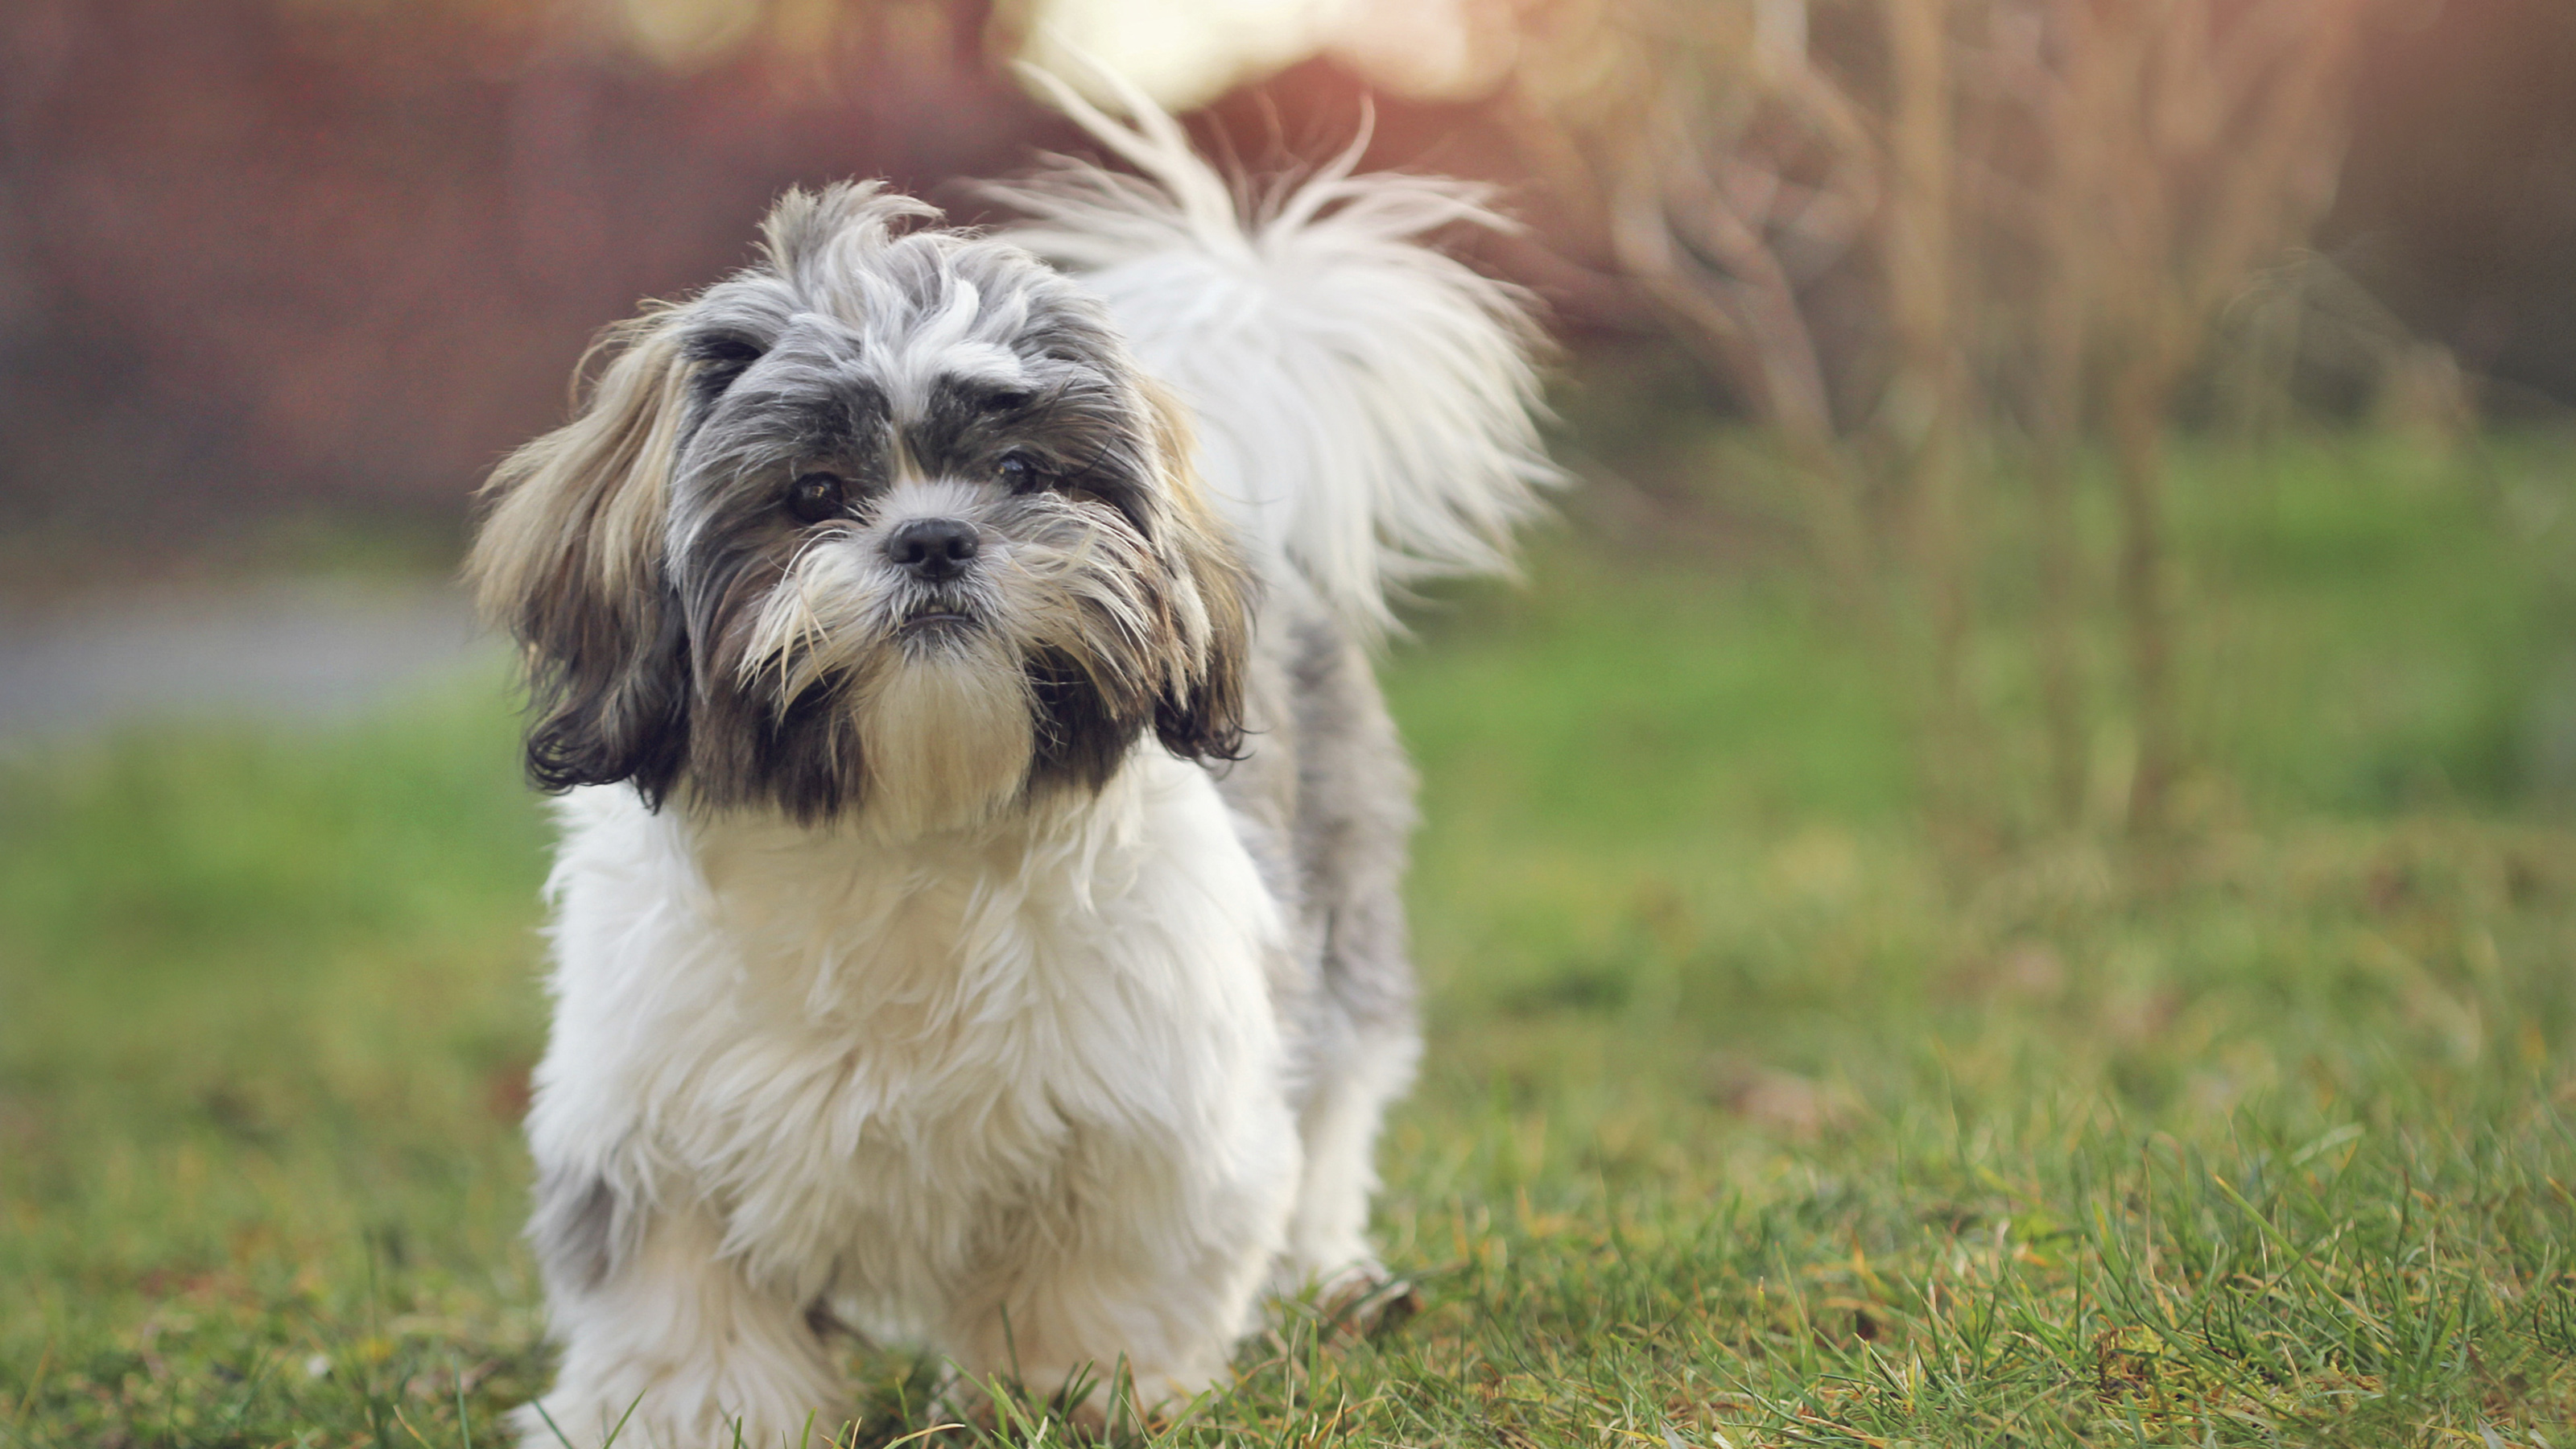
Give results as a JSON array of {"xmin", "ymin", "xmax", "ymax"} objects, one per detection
[{"xmin": 1146, "ymin": 390, "xmax": 1254, "ymax": 761}]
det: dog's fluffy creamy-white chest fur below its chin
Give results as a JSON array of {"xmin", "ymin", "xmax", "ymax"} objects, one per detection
[{"xmin": 533, "ymin": 750, "xmax": 1293, "ymax": 1333}]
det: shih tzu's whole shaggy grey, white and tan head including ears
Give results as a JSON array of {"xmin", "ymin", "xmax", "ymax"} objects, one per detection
[{"xmin": 469, "ymin": 186, "xmax": 1247, "ymax": 833}]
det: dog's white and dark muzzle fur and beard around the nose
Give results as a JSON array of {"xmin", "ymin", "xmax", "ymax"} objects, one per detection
[{"xmin": 734, "ymin": 485, "xmax": 1183, "ymax": 836}]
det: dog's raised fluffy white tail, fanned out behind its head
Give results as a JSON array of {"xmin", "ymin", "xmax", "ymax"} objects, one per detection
[{"xmin": 992, "ymin": 69, "xmax": 1558, "ymax": 632}]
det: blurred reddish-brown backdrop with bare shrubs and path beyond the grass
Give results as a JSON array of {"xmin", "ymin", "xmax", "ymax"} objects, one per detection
[{"xmin": 0, "ymin": 0, "xmax": 2576, "ymax": 830}]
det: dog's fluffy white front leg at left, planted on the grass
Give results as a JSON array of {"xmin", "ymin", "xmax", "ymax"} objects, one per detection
[{"xmin": 515, "ymin": 1207, "xmax": 845, "ymax": 1449}]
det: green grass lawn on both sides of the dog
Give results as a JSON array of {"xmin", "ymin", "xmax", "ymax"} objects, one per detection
[{"xmin": 0, "ymin": 430, "xmax": 2576, "ymax": 1449}]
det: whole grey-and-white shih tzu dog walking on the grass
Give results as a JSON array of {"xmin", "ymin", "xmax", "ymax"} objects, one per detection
[{"xmin": 469, "ymin": 88, "xmax": 1550, "ymax": 1449}]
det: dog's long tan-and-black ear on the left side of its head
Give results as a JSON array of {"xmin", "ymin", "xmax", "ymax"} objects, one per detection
[{"xmin": 466, "ymin": 312, "xmax": 700, "ymax": 804}]
